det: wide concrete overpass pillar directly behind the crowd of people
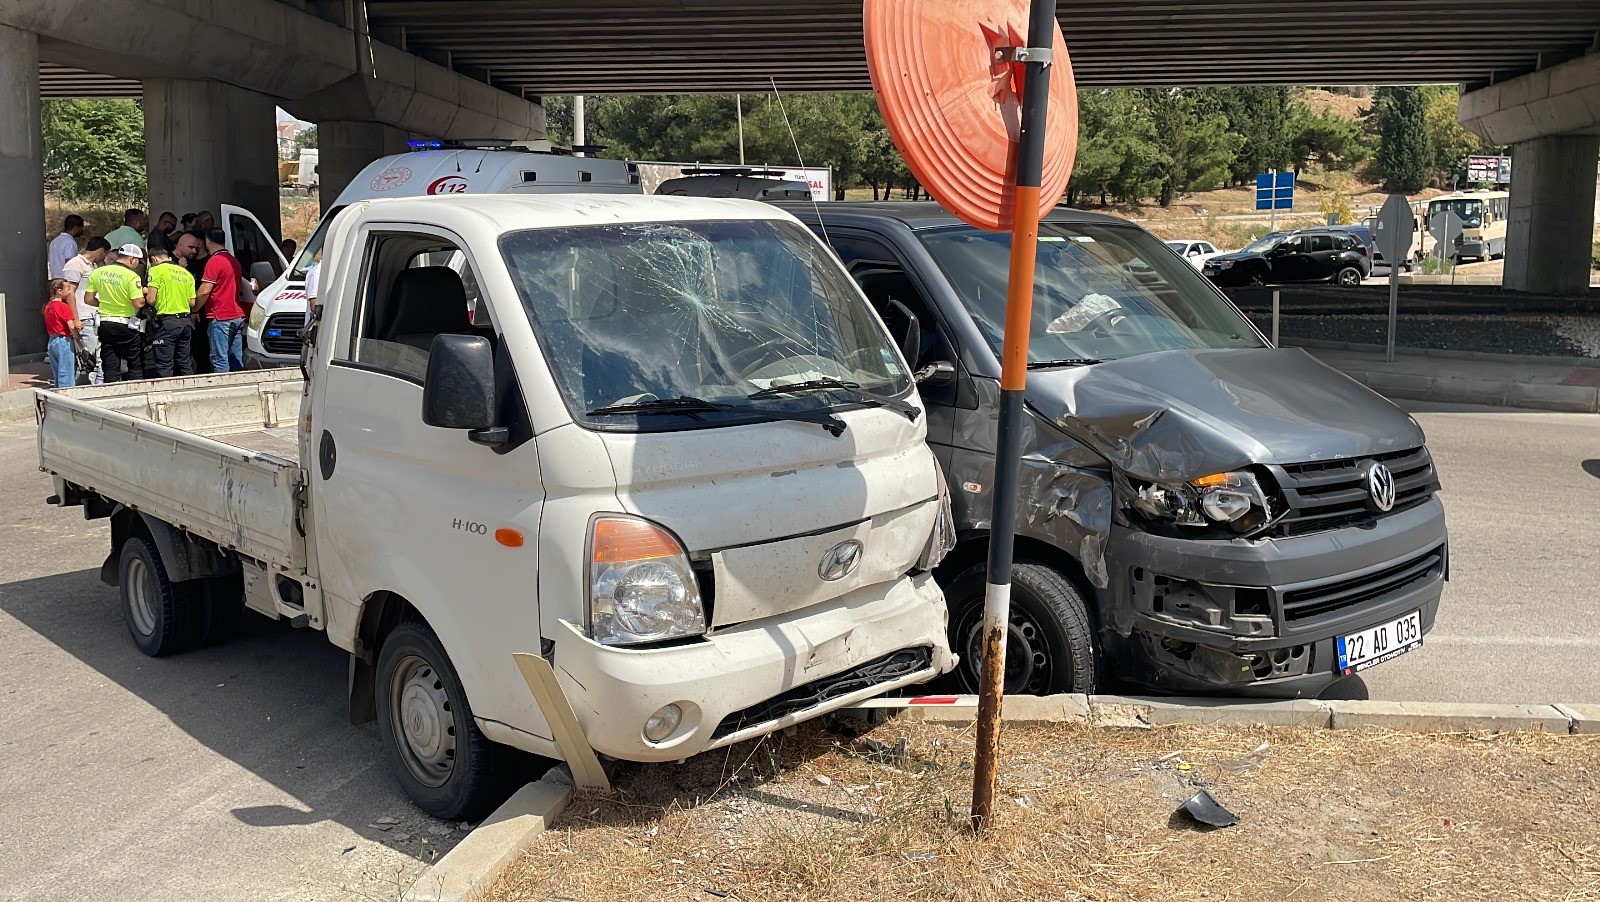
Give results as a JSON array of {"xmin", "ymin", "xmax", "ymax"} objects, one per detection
[{"xmin": 144, "ymin": 78, "xmax": 280, "ymax": 237}]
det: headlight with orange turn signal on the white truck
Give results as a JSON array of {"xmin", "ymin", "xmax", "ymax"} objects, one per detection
[{"xmin": 589, "ymin": 515, "xmax": 706, "ymax": 645}]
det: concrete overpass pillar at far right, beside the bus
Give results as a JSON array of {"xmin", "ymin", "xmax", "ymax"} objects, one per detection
[{"xmin": 1501, "ymin": 134, "xmax": 1600, "ymax": 294}]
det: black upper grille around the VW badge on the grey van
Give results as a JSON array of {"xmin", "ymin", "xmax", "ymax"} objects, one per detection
[{"xmin": 1270, "ymin": 448, "xmax": 1438, "ymax": 536}]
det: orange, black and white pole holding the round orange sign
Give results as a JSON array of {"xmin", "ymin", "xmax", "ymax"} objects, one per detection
[{"xmin": 973, "ymin": 0, "xmax": 1056, "ymax": 830}]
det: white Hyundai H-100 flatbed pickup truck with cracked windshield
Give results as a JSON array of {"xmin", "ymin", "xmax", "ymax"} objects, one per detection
[{"xmin": 38, "ymin": 195, "xmax": 954, "ymax": 819}]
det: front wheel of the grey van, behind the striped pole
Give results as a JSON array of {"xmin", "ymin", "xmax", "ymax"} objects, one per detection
[{"xmin": 944, "ymin": 561, "xmax": 1099, "ymax": 696}]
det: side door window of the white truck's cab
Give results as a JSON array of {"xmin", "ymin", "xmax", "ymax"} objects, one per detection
[{"xmin": 350, "ymin": 232, "xmax": 480, "ymax": 385}]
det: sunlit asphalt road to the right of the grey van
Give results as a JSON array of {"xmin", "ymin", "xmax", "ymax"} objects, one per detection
[{"xmin": 1365, "ymin": 403, "xmax": 1600, "ymax": 704}]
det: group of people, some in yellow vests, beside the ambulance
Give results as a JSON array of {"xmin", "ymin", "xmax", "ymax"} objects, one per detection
[{"xmin": 43, "ymin": 210, "xmax": 254, "ymax": 389}]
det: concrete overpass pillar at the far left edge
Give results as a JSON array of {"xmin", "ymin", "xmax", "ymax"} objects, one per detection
[{"xmin": 0, "ymin": 26, "xmax": 45, "ymax": 357}]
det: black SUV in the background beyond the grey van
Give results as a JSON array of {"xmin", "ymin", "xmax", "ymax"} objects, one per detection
[{"xmin": 1200, "ymin": 229, "xmax": 1373, "ymax": 288}]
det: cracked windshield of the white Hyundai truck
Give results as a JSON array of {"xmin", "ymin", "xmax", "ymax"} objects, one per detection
[{"xmin": 501, "ymin": 219, "xmax": 910, "ymax": 430}]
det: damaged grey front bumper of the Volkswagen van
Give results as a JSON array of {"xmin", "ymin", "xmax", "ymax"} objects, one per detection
[{"xmin": 1104, "ymin": 497, "xmax": 1450, "ymax": 697}]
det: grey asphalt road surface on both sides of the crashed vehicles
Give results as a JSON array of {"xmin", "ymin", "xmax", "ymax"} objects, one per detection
[{"xmin": 0, "ymin": 406, "xmax": 1600, "ymax": 902}]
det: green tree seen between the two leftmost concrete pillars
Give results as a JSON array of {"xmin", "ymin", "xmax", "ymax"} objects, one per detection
[{"xmin": 40, "ymin": 101, "xmax": 147, "ymax": 206}]
